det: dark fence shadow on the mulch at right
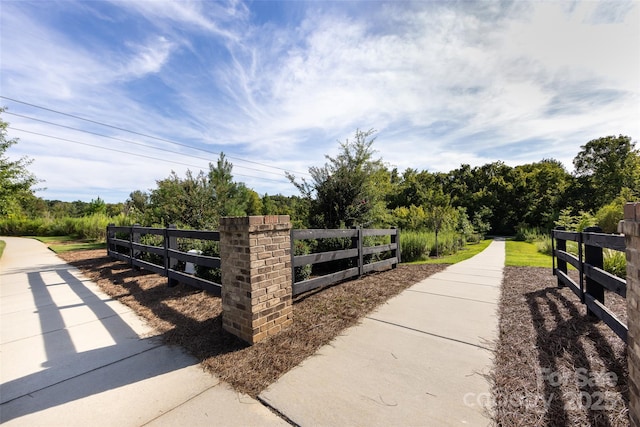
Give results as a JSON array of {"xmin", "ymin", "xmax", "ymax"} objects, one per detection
[{"xmin": 525, "ymin": 287, "xmax": 627, "ymax": 426}]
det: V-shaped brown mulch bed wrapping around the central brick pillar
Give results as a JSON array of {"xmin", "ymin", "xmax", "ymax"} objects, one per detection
[{"xmin": 60, "ymin": 250, "xmax": 446, "ymax": 396}]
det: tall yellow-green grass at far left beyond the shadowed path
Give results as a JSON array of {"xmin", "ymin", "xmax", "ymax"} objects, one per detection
[{"xmin": 0, "ymin": 214, "xmax": 133, "ymax": 242}]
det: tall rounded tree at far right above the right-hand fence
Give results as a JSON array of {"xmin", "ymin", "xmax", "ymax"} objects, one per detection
[{"xmin": 573, "ymin": 135, "xmax": 640, "ymax": 210}]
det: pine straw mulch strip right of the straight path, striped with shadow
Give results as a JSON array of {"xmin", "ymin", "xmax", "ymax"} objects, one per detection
[{"xmin": 491, "ymin": 267, "xmax": 629, "ymax": 426}]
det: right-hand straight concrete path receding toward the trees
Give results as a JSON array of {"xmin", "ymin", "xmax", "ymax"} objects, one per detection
[{"xmin": 259, "ymin": 241, "xmax": 505, "ymax": 426}]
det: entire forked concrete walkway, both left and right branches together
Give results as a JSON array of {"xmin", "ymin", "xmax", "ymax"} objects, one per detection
[{"xmin": 0, "ymin": 237, "xmax": 505, "ymax": 426}]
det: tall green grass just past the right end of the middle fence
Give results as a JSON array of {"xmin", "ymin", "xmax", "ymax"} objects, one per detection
[{"xmin": 400, "ymin": 231, "xmax": 466, "ymax": 262}]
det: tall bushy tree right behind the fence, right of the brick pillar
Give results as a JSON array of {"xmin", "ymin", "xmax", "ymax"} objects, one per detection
[{"xmin": 287, "ymin": 129, "xmax": 390, "ymax": 228}]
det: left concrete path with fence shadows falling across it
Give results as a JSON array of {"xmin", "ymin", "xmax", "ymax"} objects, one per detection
[{"xmin": 0, "ymin": 237, "xmax": 288, "ymax": 426}]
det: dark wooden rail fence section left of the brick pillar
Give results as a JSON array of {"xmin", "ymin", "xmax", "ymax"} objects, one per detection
[{"xmin": 107, "ymin": 225, "xmax": 221, "ymax": 296}]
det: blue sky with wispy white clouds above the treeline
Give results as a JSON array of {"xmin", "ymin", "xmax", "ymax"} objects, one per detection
[{"xmin": 0, "ymin": 0, "xmax": 640, "ymax": 202}]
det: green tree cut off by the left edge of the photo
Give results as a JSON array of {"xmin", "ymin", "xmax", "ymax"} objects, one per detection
[{"xmin": 0, "ymin": 108, "xmax": 39, "ymax": 216}]
